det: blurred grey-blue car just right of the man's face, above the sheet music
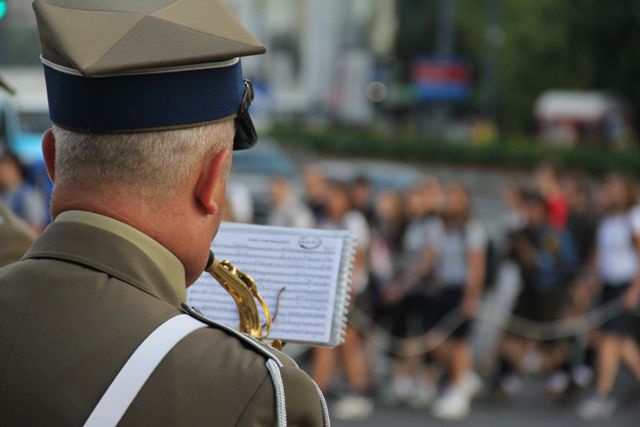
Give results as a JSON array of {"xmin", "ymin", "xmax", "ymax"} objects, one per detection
[{"xmin": 228, "ymin": 139, "xmax": 300, "ymax": 224}]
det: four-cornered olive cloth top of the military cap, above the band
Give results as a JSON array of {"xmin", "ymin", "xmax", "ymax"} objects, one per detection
[{"xmin": 33, "ymin": 0, "xmax": 266, "ymax": 77}]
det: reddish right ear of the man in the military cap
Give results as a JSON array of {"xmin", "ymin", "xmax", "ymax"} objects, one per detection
[{"xmin": 194, "ymin": 148, "xmax": 232, "ymax": 215}]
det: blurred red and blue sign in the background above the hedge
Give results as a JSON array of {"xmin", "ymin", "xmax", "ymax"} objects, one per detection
[{"xmin": 411, "ymin": 57, "xmax": 471, "ymax": 102}]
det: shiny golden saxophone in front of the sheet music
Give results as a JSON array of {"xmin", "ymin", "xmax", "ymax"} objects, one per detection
[{"xmin": 205, "ymin": 252, "xmax": 283, "ymax": 348}]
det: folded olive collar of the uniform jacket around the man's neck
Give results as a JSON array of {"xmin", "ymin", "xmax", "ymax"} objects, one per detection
[{"xmin": 25, "ymin": 211, "xmax": 186, "ymax": 306}]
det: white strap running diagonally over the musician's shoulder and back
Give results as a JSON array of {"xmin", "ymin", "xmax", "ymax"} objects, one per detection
[{"xmin": 84, "ymin": 314, "xmax": 207, "ymax": 427}]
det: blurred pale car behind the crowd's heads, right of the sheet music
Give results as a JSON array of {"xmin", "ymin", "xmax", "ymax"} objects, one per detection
[{"xmin": 316, "ymin": 159, "xmax": 426, "ymax": 192}]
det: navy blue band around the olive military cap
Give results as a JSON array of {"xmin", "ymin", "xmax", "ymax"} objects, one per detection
[{"xmin": 44, "ymin": 61, "xmax": 245, "ymax": 133}]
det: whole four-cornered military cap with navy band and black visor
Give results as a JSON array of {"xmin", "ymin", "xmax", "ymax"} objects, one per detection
[{"xmin": 33, "ymin": 0, "xmax": 265, "ymax": 148}]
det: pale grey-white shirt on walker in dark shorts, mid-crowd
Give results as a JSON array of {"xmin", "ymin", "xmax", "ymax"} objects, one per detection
[{"xmin": 431, "ymin": 218, "xmax": 489, "ymax": 288}]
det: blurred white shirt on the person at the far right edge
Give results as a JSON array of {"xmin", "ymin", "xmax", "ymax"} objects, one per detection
[{"xmin": 596, "ymin": 206, "xmax": 640, "ymax": 286}]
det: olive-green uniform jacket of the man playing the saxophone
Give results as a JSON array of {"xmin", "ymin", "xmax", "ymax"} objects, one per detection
[{"xmin": 0, "ymin": 214, "xmax": 328, "ymax": 426}]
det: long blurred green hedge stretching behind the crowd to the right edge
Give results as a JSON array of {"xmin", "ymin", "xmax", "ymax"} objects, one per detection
[{"xmin": 270, "ymin": 126, "xmax": 640, "ymax": 175}]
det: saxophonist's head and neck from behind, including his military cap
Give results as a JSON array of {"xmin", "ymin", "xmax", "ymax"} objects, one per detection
[{"xmin": 33, "ymin": 0, "xmax": 266, "ymax": 283}]
